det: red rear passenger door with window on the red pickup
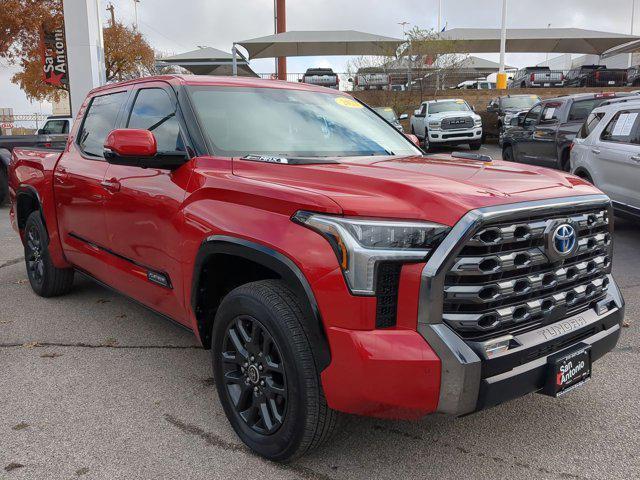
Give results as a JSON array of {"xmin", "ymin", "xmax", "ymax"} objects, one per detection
[{"xmin": 53, "ymin": 91, "xmax": 128, "ymax": 274}]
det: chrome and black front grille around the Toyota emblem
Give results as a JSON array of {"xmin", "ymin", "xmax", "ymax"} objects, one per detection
[{"xmin": 443, "ymin": 207, "xmax": 612, "ymax": 339}]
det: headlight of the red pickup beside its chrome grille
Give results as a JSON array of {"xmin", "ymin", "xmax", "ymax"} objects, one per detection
[{"xmin": 292, "ymin": 212, "xmax": 450, "ymax": 295}]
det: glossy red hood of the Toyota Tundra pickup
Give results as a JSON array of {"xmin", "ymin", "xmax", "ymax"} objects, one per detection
[{"xmin": 233, "ymin": 155, "xmax": 600, "ymax": 225}]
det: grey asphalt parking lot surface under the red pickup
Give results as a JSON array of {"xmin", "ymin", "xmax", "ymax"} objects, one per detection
[{"xmin": 0, "ymin": 179, "xmax": 640, "ymax": 480}]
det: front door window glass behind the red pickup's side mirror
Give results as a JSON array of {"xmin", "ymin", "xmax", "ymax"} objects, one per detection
[{"xmin": 127, "ymin": 88, "xmax": 185, "ymax": 152}]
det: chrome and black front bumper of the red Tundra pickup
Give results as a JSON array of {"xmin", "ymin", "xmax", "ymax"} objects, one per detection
[{"xmin": 418, "ymin": 277, "xmax": 624, "ymax": 415}]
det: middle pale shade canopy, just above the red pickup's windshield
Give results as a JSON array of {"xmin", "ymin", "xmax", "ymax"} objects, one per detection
[{"xmin": 232, "ymin": 30, "xmax": 404, "ymax": 75}]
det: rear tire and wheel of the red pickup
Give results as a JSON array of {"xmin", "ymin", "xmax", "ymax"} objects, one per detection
[{"xmin": 24, "ymin": 211, "xmax": 74, "ymax": 298}]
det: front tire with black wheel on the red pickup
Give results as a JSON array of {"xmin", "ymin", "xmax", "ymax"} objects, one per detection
[{"xmin": 212, "ymin": 280, "xmax": 339, "ymax": 462}]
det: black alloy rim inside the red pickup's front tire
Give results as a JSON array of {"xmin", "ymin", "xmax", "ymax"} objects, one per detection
[{"xmin": 222, "ymin": 315, "xmax": 288, "ymax": 435}]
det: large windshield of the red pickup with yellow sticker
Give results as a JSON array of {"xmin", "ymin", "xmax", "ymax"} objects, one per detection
[{"xmin": 187, "ymin": 86, "xmax": 422, "ymax": 158}]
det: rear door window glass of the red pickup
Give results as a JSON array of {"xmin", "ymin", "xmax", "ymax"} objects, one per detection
[{"xmin": 78, "ymin": 92, "xmax": 127, "ymax": 157}]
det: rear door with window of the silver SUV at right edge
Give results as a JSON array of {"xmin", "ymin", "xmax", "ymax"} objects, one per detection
[{"xmin": 592, "ymin": 109, "xmax": 640, "ymax": 208}]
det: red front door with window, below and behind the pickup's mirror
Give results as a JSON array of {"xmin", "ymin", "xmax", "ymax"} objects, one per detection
[{"xmin": 104, "ymin": 82, "xmax": 190, "ymax": 320}]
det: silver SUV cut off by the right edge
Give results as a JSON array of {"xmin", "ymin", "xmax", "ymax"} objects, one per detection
[{"xmin": 571, "ymin": 97, "xmax": 640, "ymax": 220}]
